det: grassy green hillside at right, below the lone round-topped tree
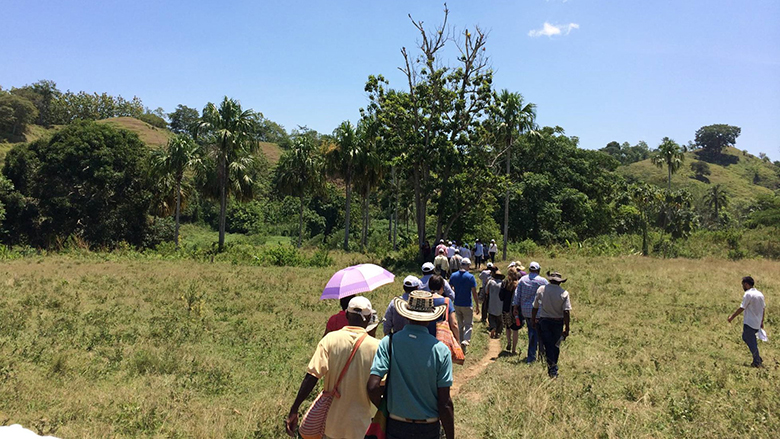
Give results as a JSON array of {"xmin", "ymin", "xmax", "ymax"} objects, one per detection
[{"xmin": 618, "ymin": 148, "xmax": 780, "ymax": 204}]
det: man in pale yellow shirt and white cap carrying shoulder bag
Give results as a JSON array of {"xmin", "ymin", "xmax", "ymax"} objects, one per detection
[{"xmin": 285, "ymin": 296, "xmax": 382, "ymax": 439}]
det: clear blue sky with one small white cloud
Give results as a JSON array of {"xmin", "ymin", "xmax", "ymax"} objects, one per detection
[{"xmin": 0, "ymin": 0, "xmax": 780, "ymax": 160}]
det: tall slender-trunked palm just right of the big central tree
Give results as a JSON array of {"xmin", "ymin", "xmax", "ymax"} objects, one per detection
[{"xmin": 495, "ymin": 89, "xmax": 536, "ymax": 261}]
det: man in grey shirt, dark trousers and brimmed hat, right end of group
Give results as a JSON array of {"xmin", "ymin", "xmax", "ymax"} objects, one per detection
[{"xmin": 531, "ymin": 271, "xmax": 571, "ymax": 378}]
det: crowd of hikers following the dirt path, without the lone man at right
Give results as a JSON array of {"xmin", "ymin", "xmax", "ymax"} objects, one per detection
[{"xmin": 285, "ymin": 258, "xmax": 571, "ymax": 439}]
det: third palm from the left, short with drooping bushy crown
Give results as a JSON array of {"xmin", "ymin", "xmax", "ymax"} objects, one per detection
[{"xmin": 274, "ymin": 135, "xmax": 325, "ymax": 247}]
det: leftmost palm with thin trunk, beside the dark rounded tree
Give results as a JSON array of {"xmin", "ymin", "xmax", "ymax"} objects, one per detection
[{"xmin": 152, "ymin": 134, "xmax": 201, "ymax": 250}]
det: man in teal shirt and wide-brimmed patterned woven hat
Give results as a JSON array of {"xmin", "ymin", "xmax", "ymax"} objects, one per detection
[{"xmin": 366, "ymin": 290, "xmax": 457, "ymax": 439}]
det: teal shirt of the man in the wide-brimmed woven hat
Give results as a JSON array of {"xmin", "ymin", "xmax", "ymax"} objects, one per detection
[{"xmin": 371, "ymin": 325, "xmax": 452, "ymax": 419}]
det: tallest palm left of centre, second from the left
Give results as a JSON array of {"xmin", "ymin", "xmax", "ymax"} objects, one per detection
[{"xmin": 195, "ymin": 96, "xmax": 259, "ymax": 251}]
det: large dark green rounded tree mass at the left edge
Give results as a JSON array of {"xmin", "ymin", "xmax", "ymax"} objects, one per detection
[{"xmin": 3, "ymin": 122, "xmax": 149, "ymax": 246}]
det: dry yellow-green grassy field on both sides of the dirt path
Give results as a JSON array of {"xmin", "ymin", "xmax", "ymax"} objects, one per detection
[{"xmin": 0, "ymin": 253, "xmax": 780, "ymax": 439}]
